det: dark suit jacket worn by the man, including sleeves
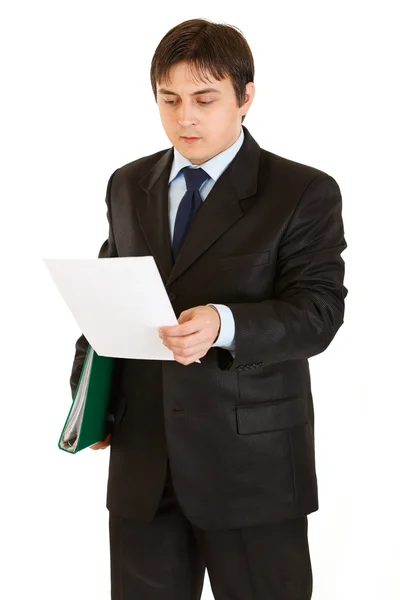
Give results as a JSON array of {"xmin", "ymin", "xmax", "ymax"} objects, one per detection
[{"xmin": 70, "ymin": 127, "xmax": 347, "ymax": 529}]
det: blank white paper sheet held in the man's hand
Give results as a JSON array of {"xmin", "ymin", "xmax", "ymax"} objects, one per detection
[{"xmin": 44, "ymin": 256, "xmax": 188, "ymax": 362}]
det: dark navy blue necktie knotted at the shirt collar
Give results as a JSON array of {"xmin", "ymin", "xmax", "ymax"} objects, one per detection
[{"xmin": 172, "ymin": 167, "xmax": 209, "ymax": 261}]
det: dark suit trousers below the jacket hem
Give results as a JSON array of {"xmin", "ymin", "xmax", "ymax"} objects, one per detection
[{"xmin": 109, "ymin": 463, "xmax": 313, "ymax": 600}]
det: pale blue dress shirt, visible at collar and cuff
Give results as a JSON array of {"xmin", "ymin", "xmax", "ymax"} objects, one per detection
[{"xmin": 168, "ymin": 127, "xmax": 244, "ymax": 356}]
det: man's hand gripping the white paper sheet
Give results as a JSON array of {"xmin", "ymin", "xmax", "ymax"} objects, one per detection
[{"xmin": 158, "ymin": 306, "xmax": 221, "ymax": 365}]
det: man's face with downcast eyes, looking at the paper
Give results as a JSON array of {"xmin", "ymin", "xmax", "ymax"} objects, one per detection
[{"xmin": 157, "ymin": 62, "xmax": 255, "ymax": 165}]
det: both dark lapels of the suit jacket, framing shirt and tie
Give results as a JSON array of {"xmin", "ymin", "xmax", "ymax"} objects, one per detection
[{"xmin": 136, "ymin": 126, "xmax": 261, "ymax": 285}]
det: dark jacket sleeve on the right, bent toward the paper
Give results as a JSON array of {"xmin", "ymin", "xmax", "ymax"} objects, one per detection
[{"xmin": 222, "ymin": 173, "xmax": 348, "ymax": 370}]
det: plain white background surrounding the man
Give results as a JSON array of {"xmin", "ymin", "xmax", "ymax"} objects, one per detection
[{"xmin": 0, "ymin": 0, "xmax": 400, "ymax": 600}]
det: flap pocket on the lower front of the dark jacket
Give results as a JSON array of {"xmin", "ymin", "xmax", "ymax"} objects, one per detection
[{"xmin": 236, "ymin": 396, "xmax": 308, "ymax": 435}]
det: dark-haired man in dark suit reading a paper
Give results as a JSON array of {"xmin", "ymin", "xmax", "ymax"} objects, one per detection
[{"xmin": 71, "ymin": 19, "xmax": 347, "ymax": 600}]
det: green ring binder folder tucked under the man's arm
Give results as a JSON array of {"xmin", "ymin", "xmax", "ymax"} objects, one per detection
[{"xmin": 58, "ymin": 345, "xmax": 114, "ymax": 454}]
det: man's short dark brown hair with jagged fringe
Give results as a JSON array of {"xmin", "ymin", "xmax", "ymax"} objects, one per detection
[{"xmin": 150, "ymin": 19, "xmax": 254, "ymax": 123}]
